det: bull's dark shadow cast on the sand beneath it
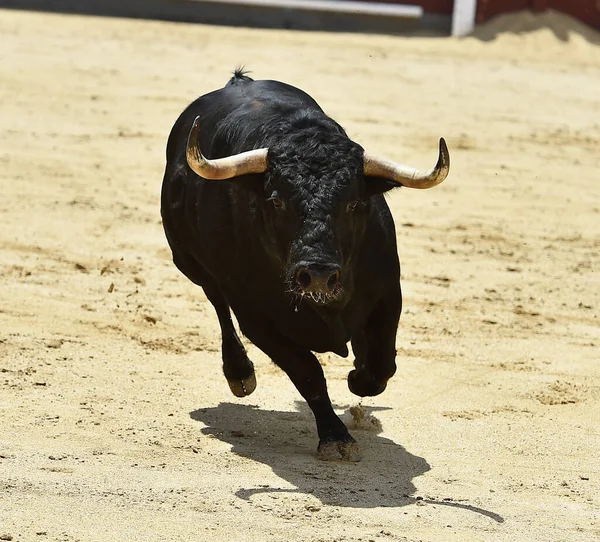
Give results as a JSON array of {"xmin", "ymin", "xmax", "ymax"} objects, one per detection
[{"xmin": 190, "ymin": 403, "xmax": 430, "ymax": 508}]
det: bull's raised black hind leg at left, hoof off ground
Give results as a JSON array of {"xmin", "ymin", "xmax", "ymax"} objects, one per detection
[{"xmin": 174, "ymin": 258, "xmax": 256, "ymax": 397}]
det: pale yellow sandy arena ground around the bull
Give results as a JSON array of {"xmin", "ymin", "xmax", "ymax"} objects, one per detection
[{"xmin": 0, "ymin": 11, "xmax": 600, "ymax": 542}]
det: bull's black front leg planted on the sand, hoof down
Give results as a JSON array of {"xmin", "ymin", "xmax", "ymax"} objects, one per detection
[{"xmin": 234, "ymin": 307, "xmax": 361, "ymax": 461}]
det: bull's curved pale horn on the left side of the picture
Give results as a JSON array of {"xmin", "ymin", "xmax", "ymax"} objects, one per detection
[{"xmin": 186, "ymin": 117, "xmax": 269, "ymax": 181}]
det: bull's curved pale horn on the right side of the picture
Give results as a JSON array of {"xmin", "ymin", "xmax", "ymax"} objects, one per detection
[{"xmin": 364, "ymin": 137, "xmax": 450, "ymax": 188}]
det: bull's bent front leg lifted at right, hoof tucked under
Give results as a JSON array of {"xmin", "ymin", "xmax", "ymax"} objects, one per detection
[{"xmin": 348, "ymin": 283, "xmax": 402, "ymax": 397}]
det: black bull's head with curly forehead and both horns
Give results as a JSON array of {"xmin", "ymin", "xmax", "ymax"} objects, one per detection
[{"xmin": 187, "ymin": 117, "xmax": 450, "ymax": 304}]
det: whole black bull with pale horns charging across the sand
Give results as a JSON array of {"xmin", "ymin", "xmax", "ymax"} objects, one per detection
[{"xmin": 161, "ymin": 71, "xmax": 449, "ymax": 461}]
